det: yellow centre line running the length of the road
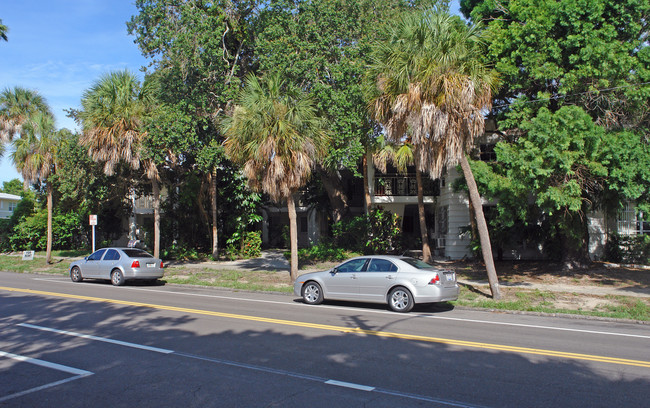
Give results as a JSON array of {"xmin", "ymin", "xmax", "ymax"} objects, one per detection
[{"xmin": 5, "ymin": 286, "xmax": 650, "ymax": 368}]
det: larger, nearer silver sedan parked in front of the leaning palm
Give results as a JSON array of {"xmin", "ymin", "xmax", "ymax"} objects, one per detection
[{"xmin": 293, "ymin": 255, "xmax": 459, "ymax": 313}]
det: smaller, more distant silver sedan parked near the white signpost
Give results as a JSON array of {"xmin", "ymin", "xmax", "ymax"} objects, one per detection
[{"xmin": 69, "ymin": 248, "xmax": 164, "ymax": 286}]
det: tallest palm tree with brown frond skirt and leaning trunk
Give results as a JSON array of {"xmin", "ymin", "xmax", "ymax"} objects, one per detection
[{"xmin": 368, "ymin": 9, "xmax": 500, "ymax": 299}]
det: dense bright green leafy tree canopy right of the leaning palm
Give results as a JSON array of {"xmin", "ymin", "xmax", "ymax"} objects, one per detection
[{"xmin": 461, "ymin": 0, "xmax": 650, "ymax": 260}]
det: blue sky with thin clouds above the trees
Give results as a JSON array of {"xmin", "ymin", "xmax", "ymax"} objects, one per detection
[{"xmin": 0, "ymin": 0, "xmax": 458, "ymax": 187}]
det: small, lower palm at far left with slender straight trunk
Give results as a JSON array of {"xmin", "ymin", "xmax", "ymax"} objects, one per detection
[{"xmin": 11, "ymin": 112, "xmax": 59, "ymax": 263}]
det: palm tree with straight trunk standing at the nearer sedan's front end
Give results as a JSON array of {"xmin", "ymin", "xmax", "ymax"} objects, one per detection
[{"xmin": 222, "ymin": 74, "xmax": 329, "ymax": 282}]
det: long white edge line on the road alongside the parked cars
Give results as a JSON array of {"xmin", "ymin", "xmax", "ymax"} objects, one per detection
[{"xmin": 34, "ymin": 278, "xmax": 650, "ymax": 339}]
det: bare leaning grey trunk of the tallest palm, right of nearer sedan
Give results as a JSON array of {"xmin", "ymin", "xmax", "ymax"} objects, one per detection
[{"xmin": 460, "ymin": 154, "xmax": 501, "ymax": 300}]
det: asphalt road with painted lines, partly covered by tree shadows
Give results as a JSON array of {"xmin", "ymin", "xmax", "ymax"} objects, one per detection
[{"xmin": 0, "ymin": 272, "xmax": 650, "ymax": 408}]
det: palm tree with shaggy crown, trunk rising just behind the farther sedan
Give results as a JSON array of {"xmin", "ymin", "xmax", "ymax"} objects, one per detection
[{"xmin": 79, "ymin": 70, "xmax": 160, "ymax": 257}]
